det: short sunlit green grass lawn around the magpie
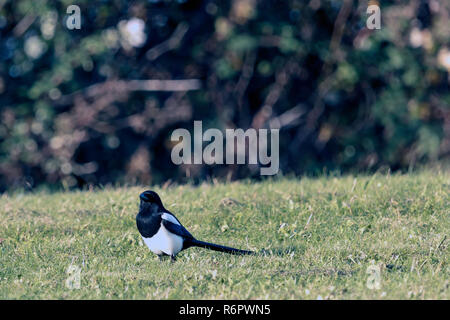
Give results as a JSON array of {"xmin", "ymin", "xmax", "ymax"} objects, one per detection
[{"xmin": 0, "ymin": 170, "xmax": 450, "ymax": 299}]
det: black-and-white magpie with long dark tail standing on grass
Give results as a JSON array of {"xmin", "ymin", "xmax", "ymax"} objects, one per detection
[{"xmin": 136, "ymin": 190, "xmax": 254, "ymax": 261}]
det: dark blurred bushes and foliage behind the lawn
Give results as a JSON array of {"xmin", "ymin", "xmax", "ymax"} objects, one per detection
[{"xmin": 0, "ymin": 0, "xmax": 450, "ymax": 191}]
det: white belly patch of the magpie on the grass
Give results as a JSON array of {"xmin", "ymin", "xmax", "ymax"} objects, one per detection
[{"xmin": 142, "ymin": 224, "xmax": 183, "ymax": 256}]
